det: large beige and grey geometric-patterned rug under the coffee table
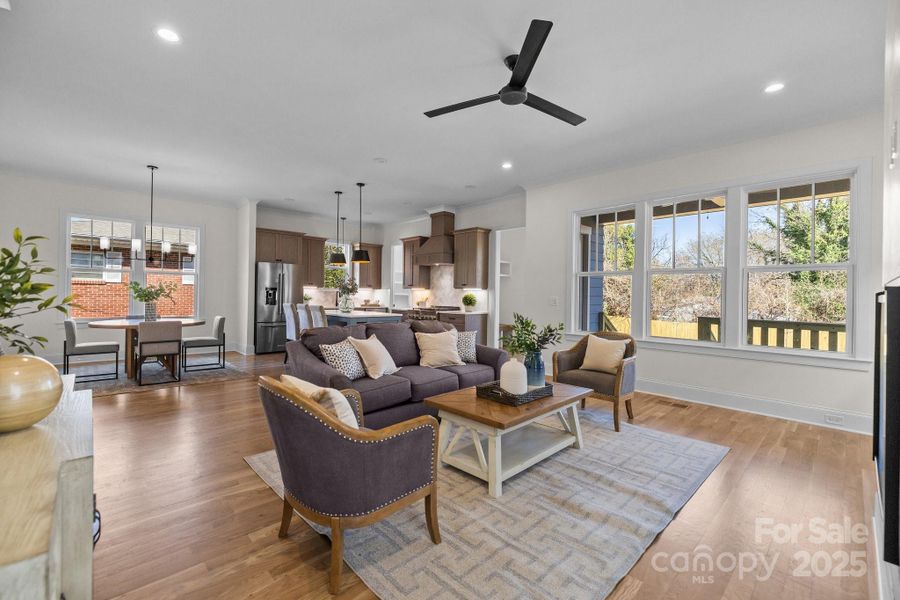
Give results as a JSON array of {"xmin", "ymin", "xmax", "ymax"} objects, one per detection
[{"xmin": 245, "ymin": 409, "xmax": 729, "ymax": 600}]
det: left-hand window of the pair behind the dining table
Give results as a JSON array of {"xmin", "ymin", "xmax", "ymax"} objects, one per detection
[{"xmin": 66, "ymin": 217, "xmax": 134, "ymax": 319}]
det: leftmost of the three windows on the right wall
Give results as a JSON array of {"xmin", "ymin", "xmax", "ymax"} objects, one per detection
[{"xmin": 576, "ymin": 208, "xmax": 635, "ymax": 333}]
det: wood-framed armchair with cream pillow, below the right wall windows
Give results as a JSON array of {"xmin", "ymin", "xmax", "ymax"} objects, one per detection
[{"xmin": 553, "ymin": 331, "xmax": 637, "ymax": 431}]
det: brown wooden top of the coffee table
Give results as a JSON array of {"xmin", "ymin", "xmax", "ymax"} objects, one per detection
[{"xmin": 425, "ymin": 383, "xmax": 592, "ymax": 429}]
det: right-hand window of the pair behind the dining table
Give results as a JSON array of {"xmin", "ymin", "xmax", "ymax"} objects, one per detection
[{"xmin": 144, "ymin": 225, "xmax": 198, "ymax": 317}]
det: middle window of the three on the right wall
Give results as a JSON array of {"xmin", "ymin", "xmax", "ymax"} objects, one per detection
[{"xmin": 649, "ymin": 194, "xmax": 725, "ymax": 342}]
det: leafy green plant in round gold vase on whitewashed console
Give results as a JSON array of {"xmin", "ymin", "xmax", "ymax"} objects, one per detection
[{"xmin": 0, "ymin": 227, "xmax": 72, "ymax": 432}]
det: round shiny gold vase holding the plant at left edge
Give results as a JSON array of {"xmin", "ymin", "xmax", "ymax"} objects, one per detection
[{"xmin": 0, "ymin": 354, "xmax": 63, "ymax": 433}]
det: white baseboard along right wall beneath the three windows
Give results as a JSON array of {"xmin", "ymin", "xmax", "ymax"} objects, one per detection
[{"xmin": 635, "ymin": 378, "xmax": 872, "ymax": 435}]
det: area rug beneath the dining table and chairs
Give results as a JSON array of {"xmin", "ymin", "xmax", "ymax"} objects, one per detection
[{"xmin": 68, "ymin": 357, "xmax": 253, "ymax": 398}]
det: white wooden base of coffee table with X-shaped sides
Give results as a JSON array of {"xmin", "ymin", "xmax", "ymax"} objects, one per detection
[{"xmin": 438, "ymin": 400, "xmax": 582, "ymax": 498}]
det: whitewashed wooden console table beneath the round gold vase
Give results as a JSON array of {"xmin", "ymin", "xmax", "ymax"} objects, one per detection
[{"xmin": 0, "ymin": 375, "xmax": 94, "ymax": 600}]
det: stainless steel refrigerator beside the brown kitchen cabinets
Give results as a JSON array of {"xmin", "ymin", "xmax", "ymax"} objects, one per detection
[{"xmin": 254, "ymin": 262, "xmax": 303, "ymax": 354}]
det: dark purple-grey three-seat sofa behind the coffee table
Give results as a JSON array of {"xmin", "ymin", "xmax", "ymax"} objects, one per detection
[{"xmin": 287, "ymin": 321, "xmax": 509, "ymax": 429}]
